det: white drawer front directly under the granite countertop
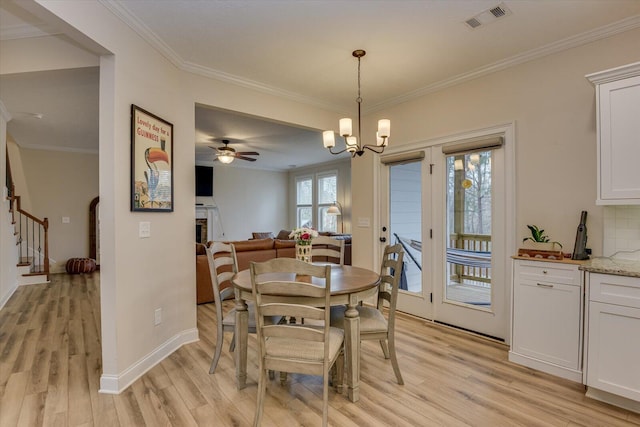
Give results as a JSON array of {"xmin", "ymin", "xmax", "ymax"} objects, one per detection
[{"xmin": 589, "ymin": 273, "xmax": 640, "ymax": 308}]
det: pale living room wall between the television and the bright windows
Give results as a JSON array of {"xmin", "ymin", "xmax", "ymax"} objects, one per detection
[{"xmin": 213, "ymin": 165, "xmax": 288, "ymax": 240}]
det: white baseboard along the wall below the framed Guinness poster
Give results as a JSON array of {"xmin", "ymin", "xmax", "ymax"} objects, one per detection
[{"xmin": 99, "ymin": 328, "xmax": 200, "ymax": 394}]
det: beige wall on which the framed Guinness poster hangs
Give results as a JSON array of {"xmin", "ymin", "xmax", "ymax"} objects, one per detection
[{"xmin": 36, "ymin": 0, "xmax": 339, "ymax": 392}]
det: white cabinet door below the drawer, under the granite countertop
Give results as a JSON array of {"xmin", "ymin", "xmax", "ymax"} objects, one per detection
[{"xmin": 587, "ymin": 301, "xmax": 640, "ymax": 401}]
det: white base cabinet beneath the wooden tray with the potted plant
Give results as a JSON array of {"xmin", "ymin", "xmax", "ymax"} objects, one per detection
[{"xmin": 509, "ymin": 259, "xmax": 584, "ymax": 382}]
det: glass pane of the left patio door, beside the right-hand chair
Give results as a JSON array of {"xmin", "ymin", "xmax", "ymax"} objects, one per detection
[{"xmin": 389, "ymin": 162, "xmax": 422, "ymax": 293}]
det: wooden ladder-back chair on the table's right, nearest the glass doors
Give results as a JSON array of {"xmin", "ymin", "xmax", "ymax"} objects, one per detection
[{"xmin": 331, "ymin": 243, "xmax": 404, "ymax": 384}]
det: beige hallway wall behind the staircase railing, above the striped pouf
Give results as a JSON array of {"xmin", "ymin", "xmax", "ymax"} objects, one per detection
[{"xmin": 20, "ymin": 149, "xmax": 98, "ymax": 273}]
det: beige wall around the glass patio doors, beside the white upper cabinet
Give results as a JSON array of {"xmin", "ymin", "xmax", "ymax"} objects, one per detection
[{"xmin": 352, "ymin": 29, "xmax": 640, "ymax": 266}]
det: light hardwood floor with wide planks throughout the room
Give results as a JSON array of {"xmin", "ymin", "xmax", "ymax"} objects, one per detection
[{"xmin": 0, "ymin": 274, "xmax": 640, "ymax": 427}]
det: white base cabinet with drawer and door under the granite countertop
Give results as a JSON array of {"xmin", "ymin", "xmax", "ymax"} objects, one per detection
[{"xmin": 585, "ymin": 273, "xmax": 640, "ymax": 410}]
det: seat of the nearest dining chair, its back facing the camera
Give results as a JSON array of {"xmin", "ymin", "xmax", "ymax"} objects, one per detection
[{"xmin": 265, "ymin": 325, "xmax": 344, "ymax": 361}]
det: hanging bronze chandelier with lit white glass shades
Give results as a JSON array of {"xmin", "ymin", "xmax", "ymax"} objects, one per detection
[{"xmin": 322, "ymin": 49, "xmax": 391, "ymax": 157}]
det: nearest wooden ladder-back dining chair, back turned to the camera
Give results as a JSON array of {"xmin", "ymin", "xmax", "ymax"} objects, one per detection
[{"xmin": 250, "ymin": 258, "xmax": 344, "ymax": 426}]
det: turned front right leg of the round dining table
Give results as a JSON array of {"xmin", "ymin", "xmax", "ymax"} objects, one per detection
[{"xmin": 344, "ymin": 298, "xmax": 360, "ymax": 402}]
